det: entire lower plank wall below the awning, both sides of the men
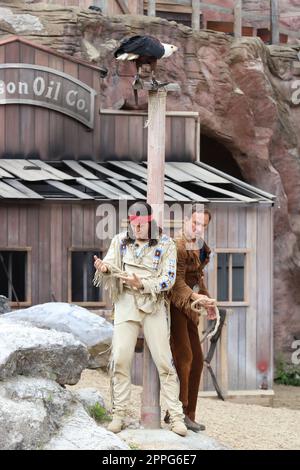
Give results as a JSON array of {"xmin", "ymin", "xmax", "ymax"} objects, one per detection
[{"xmin": 0, "ymin": 203, "xmax": 273, "ymax": 390}]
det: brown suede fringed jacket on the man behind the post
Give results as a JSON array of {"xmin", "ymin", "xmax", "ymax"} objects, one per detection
[{"xmin": 169, "ymin": 236, "xmax": 211, "ymax": 318}]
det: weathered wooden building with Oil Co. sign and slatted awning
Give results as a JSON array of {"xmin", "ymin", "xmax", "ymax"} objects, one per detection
[{"xmin": 0, "ymin": 37, "xmax": 274, "ymax": 391}]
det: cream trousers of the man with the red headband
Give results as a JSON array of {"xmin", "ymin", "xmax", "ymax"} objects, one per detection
[{"xmin": 112, "ymin": 309, "xmax": 184, "ymax": 421}]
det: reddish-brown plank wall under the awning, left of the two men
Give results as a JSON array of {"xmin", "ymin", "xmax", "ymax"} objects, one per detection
[{"xmin": 0, "ymin": 203, "xmax": 110, "ymax": 306}]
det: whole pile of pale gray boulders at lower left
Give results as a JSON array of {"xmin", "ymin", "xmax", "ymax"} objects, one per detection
[{"xmin": 0, "ymin": 315, "xmax": 128, "ymax": 450}]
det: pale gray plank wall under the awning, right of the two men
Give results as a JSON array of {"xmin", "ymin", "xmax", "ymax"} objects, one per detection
[{"xmin": 132, "ymin": 206, "xmax": 273, "ymax": 391}]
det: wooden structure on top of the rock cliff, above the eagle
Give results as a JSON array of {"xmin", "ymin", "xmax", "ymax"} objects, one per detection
[{"xmin": 33, "ymin": 0, "xmax": 290, "ymax": 43}]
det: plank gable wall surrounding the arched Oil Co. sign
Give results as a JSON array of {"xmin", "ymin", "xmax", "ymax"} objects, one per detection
[{"xmin": 0, "ymin": 42, "xmax": 101, "ymax": 160}]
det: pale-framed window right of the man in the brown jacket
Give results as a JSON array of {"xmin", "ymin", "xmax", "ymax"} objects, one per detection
[{"xmin": 217, "ymin": 251, "xmax": 247, "ymax": 304}]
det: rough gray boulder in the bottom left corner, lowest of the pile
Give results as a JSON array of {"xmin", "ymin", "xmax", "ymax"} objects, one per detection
[{"xmin": 0, "ymin": 376, "xmax": 76, "ymax": 450}]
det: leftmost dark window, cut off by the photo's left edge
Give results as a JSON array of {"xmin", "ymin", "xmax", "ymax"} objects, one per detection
[{"xmin": 0, "ymin": 248, "xmax": 31, "ymax": 306}]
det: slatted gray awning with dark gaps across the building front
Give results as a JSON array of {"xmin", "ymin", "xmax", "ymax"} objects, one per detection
[{"xmin": 0, "ymin": 159, "xmax": 275, "ymax": 204}]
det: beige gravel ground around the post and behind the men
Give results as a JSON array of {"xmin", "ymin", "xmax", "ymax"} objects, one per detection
[{"xmin": 68, "ymin": 370, "xmax": 300, "ymax": 450}]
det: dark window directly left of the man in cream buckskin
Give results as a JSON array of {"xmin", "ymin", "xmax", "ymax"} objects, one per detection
[{"xmin": 69, "ymin": 249, "xmax": 102, "ymax": 306}]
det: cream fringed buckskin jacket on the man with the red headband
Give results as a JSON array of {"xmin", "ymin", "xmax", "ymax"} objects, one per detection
[{"xmin": 93, "ymin": 232, "xmax": 176, "ymax": 324}]
